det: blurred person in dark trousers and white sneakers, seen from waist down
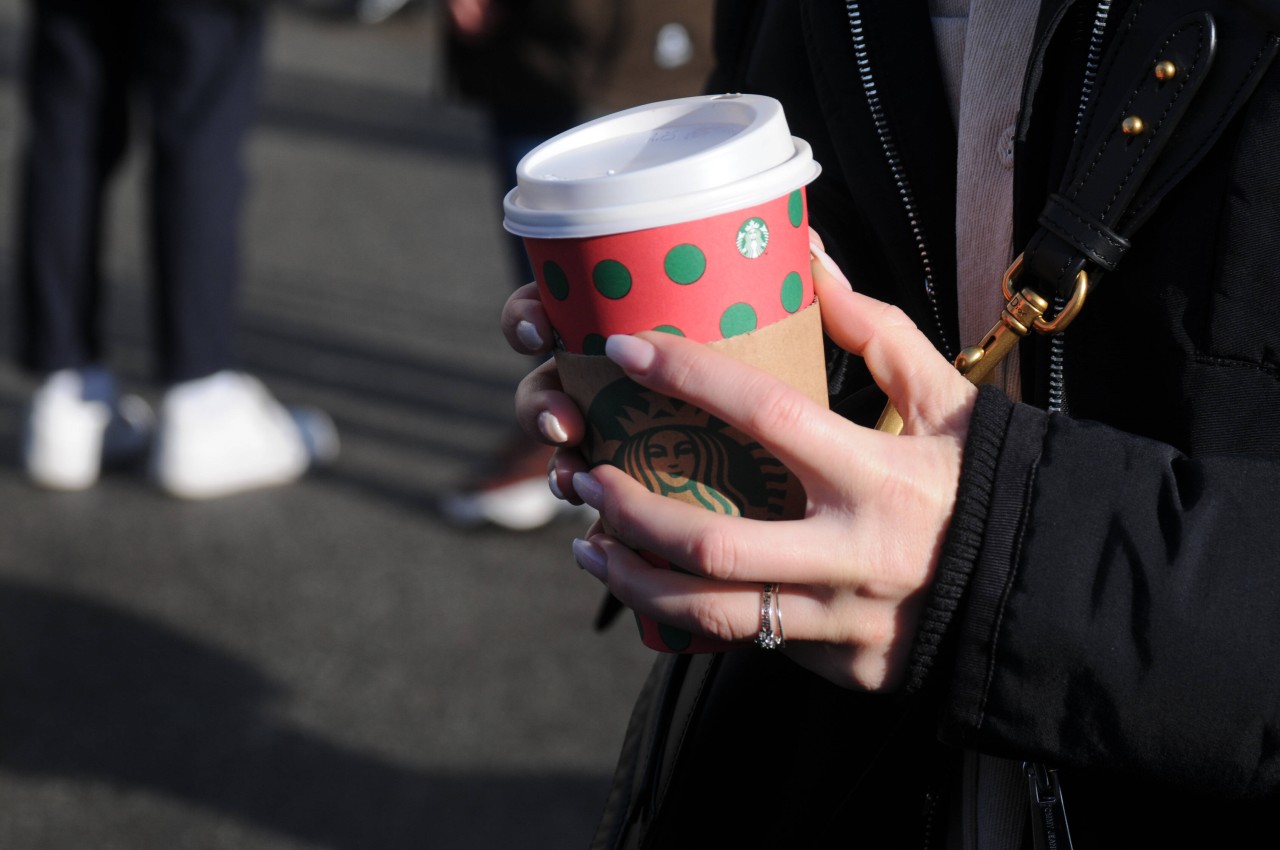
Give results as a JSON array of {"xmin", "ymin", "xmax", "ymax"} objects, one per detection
[{"xmin": 14, "ymin": 0, "xmax": 337, "ymax": 498}]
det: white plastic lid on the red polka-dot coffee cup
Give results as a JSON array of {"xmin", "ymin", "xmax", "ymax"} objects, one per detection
[{"xmin": 503, "ymin": 95, "xmax": 820, "ymax": 238}]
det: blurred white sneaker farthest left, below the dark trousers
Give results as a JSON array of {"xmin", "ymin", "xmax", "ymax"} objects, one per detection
[{"xmin": 22, "ymin": 367, "xmax": 154, "ymax": 490}]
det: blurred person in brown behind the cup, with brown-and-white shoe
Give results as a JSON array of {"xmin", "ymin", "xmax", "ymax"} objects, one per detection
[{"xmin": 440, "ymin": 0, "xmax": 713, "ymax": 530}]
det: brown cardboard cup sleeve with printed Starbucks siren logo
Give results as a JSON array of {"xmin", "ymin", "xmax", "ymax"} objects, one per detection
[{"xmin": 556, "ymin": 302, "xmax": 827, "ymax": 653}]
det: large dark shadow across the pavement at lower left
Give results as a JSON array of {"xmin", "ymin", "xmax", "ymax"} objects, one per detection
[{"xmin": 0, "ymin": 581, "xmax": 614, "ymax": 850}]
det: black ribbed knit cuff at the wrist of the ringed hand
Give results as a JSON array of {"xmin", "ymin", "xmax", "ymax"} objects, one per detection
[{"xmin": 906, "ymin": 385, "xmax": 1012, "ymax": 694}]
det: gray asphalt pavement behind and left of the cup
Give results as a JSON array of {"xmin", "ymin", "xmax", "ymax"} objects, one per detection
[{"xmin": 0, "ymin": 0, "xmax": 650, "ymax": 850}]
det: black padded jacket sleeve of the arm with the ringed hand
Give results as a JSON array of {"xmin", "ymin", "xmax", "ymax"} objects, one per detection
[{"xmin": 916, "ymin": 390, "xmax": 1280, "ymax": 799}]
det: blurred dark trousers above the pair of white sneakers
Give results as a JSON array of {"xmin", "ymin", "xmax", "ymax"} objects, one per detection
[{"xmin": 15, "ymin": 0, "xmax": 264, "ymax": 381}]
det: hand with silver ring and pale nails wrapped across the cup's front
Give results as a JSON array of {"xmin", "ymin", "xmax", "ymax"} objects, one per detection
[{"xmin": 565, "ymin": 240, "xmax": 977, "ymax": 690}]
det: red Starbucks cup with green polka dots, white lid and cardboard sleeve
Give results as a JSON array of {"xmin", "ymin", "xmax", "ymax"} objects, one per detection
[{"xmin": 504, "ymin": 95, "xmax": 827, "ymax": 652}]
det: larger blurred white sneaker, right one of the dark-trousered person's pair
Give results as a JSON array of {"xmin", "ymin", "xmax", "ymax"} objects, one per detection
[{"xmin": 151, "ymin": 371, "xmax": 338, "ymax": 499}]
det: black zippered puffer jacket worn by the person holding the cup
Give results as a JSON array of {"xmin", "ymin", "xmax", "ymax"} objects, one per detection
[{"xmin": 593, "ymin": 0, "xmax": 1280, "ymax": 850}]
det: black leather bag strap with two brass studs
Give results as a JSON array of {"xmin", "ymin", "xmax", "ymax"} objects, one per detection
[{"xmin": 1021, "ymin": 0, "xmax": 1280, "ymax": 296}]
